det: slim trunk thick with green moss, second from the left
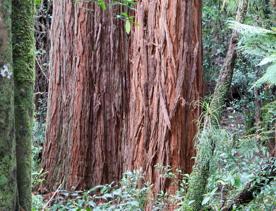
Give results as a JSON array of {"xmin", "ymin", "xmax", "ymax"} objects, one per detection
[{"xmin": 12, "ymin": 0, "xmax": 35, "ymax": 210}]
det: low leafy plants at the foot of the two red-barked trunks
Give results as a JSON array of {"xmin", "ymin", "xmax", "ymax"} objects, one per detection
[{"xmin": 33, "ymin": 170, "xmax": 181, "ymax": 211}]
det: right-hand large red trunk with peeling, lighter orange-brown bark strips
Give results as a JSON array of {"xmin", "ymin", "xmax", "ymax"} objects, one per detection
[{"xmin": 125, "ymin": 0, "xmax": 202, "ymax": 192}]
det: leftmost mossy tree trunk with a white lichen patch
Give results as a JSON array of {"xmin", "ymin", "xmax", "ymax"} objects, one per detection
[{"xmin": 0, "ymin": 0, "xmax": 16, "ymax": 211}]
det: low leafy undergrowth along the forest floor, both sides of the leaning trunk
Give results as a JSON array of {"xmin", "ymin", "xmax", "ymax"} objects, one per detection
[{"xmin": 33, "ymin": 129, "xmax": 276, "ymax": 211}]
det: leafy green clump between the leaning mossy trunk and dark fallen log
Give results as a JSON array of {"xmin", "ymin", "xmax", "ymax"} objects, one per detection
[{"xmin": 202, "ymin": 130, "xmax": 276, "ymax": 210}]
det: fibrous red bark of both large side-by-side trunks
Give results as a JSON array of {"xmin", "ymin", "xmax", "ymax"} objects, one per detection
[{"xmin": 43, "ymin": 0, "xmax": 202, "ymax": 195}]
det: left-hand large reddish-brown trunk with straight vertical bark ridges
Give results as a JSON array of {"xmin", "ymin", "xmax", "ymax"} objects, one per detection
[{"xmin": 43, "ymin": 0, "xmax": 129, "ymax": 189}]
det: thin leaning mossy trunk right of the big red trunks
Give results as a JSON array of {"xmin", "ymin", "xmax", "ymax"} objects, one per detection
[{"xmin": 187, "ymin": 0, "xmax": 248, "ymax": 211}]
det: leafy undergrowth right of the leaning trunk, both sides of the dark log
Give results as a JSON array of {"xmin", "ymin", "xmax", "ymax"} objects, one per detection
[{"xmin": 202, "ymin": 133, "xmax": 276, "ymax": 210}]
